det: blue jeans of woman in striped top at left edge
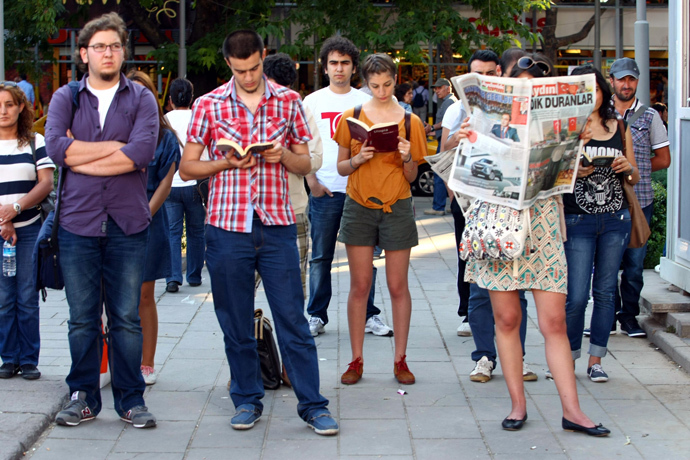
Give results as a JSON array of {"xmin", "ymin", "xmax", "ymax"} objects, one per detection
[{"xmin": 0, "ymin": 221, "xmax": 41, "ymax": 366}]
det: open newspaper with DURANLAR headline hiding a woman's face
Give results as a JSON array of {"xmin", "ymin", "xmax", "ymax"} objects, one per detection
[{"xmin": 447, "ymin": 74, "xmax": 596, "ymax": 209}]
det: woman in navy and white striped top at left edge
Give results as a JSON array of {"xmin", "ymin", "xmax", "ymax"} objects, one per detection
[{"xmin": 0, "ymin": 81, "xmax": 55, "ymax": 380}]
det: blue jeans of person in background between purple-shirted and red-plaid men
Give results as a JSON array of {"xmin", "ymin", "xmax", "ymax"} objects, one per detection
[{"xmin": 165, "ymin": 186, "xmax": 206, "ymax": 284}]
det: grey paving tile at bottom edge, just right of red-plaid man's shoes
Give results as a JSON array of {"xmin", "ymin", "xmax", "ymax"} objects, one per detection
[{"xmin": 338, "ymin": 420, "xmax": 412, "ymax": 458}]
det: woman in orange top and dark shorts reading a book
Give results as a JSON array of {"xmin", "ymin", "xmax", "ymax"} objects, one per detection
[{"xmin": 333, "ymin": 54, "xmax": 426, "ymax": 385}]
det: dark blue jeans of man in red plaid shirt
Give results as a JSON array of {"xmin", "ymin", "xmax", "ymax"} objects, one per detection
[{"xmin": 206, "ymin": 223, "xmax": 328, "ymax": 420}]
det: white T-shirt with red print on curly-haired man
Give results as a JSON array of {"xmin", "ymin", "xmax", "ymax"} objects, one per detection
[{"xmin": 304, "ymin": 88, "xmax": 371, "ymax": 193}]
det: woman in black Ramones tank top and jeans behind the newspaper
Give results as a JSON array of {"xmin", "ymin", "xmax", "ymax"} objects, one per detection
[{"xmin": 563, "ymin": 65, "xmax": 640, "ymax": 382}]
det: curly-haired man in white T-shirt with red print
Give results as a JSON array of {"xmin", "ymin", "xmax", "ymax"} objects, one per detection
[{"xmin": 304, "ymin": 36, "xmax": 393, "ymax": 336}]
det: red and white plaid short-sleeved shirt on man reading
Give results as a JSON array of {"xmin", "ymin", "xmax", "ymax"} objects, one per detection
[{"xmin": 187, "ymin": 78, "xmax": 311, "ymax": 233}]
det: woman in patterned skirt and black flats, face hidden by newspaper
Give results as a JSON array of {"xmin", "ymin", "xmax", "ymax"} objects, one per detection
[{"xmin": 461, "ymin": 54, "xmax": 610, "ymax": 436}]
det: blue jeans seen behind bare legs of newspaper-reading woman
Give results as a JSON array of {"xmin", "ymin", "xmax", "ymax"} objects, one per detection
[{"xmin": 468, "ymin": 283, "xmax": 527, "ymax": 368}]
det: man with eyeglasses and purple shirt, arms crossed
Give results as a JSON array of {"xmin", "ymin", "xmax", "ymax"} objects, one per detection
[{"xmin": 46, "ymin": 13, "xmax": 159, "ymax": 428}]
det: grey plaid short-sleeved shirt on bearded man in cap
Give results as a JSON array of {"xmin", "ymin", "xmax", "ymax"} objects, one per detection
[{"xmin": 614, "ymin": 96, "xmax": 669, "ymax": 208}]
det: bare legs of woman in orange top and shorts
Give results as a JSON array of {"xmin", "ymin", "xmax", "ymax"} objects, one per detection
[{"xmin": 345, "ymin": 244, "xmax": 412, "ymax": 362}]
